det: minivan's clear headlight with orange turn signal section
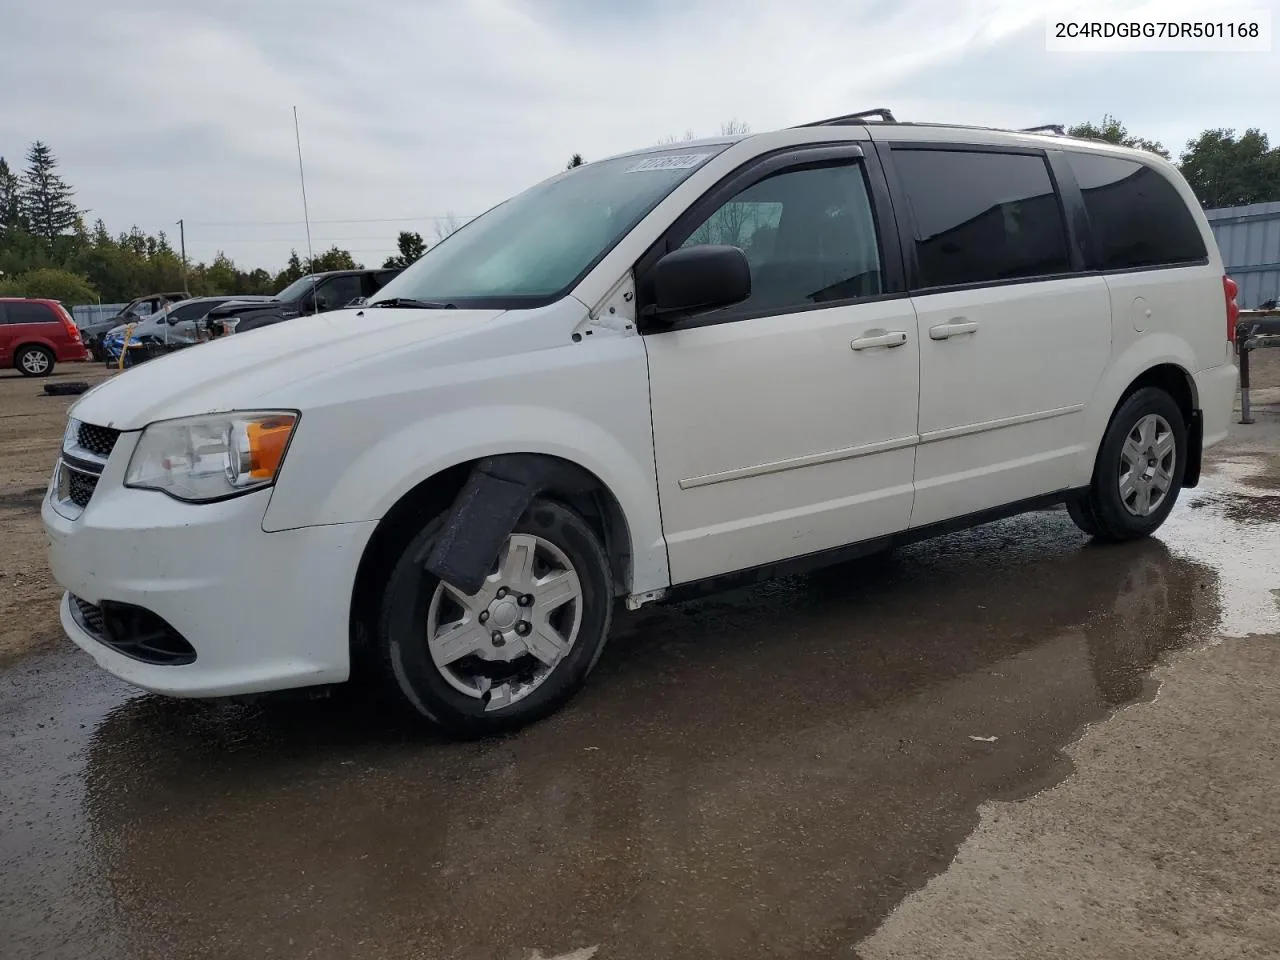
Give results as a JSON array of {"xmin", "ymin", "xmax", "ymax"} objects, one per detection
[{"xmin": 124, "ymin": 411, "xmax": 298, "ymax": 503}]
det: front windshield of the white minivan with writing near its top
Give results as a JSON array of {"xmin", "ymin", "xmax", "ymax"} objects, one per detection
[{"xmin": 370, "ymin": 143, "xmax": 728, "ymax": 307}]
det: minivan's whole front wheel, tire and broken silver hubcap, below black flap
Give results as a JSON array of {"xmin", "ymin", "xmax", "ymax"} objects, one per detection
[{"xmin": 376, "ymin": 499, "xmax": 613, "ymax": 737}]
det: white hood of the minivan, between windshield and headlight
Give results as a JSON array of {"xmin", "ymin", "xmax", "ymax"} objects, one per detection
[{"xmin": 70, "ymin": 308, "xmax": 504, "ymax": 430}]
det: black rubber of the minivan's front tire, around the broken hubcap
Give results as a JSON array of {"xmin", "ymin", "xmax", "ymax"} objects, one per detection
[{"xmin": 378, "ymin": 500, "xmax": 613, "ymax": 736}]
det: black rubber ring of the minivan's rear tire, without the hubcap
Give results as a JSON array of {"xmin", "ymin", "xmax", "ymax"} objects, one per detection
[{"xmin": 1092, "ymin": 387, "xmax": 1188, "ymax": 536}]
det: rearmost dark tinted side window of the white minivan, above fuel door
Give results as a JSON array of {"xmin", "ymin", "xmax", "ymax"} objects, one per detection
[{"xmin": 1066, "ymin": 154, "xmax": 1206, "ymax": 270}]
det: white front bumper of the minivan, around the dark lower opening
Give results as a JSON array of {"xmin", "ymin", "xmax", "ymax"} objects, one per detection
[{"xmin": 41, "ymin": 434, "xmax": 376, "ymax": 696}]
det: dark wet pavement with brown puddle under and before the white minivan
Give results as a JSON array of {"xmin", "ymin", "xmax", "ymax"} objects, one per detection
[{"xmin": 0, "ymin": 453, "xmax": 1280, "ymax": 960}]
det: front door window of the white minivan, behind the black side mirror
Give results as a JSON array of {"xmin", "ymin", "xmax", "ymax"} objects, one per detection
[{"xmin": 682, "ymin": 161, "xmax": 883, "ymax": 315}]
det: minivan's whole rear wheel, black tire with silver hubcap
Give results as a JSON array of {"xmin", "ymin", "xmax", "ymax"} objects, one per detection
[{"xmin": 1068, "ymin": 387, "xmax": 1188, "ymax": 543}]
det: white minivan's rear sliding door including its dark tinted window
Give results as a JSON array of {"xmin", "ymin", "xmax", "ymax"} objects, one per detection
[{"xmin": 888, "ymin": 143, "xmax": 1111, "ymax": 527}]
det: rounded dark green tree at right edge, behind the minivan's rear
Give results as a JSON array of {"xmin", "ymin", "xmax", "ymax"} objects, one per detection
[{"xmin": 1180, "ymin": 127, "xmax": 1280, "ymax": 207}]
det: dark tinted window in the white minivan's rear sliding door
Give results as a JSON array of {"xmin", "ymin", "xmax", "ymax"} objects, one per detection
[{"xmin": 893, "ymin": 148, "xmax": 1071, "ymax": 287}]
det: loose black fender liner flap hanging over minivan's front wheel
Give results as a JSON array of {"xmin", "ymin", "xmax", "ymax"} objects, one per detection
[{"xmin": 415, "ymin": 453, "xmax": 596, "ymax": 594}]
